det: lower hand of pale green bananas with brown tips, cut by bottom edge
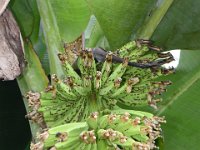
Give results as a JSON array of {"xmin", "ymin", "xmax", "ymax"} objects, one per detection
[{"xmin": 31, "ymin": 110, "xmax": 165, "ymax": 150}]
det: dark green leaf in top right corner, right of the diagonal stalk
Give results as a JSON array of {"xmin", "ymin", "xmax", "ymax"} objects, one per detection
[{"xmin": 140, "ymin": 0, "xmax": 200, "ymax": 50}]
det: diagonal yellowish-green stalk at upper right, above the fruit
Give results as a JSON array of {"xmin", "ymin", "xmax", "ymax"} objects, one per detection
[{"xmin": 135, "ymin": 0, "xmax": 174, "ymax": 39}]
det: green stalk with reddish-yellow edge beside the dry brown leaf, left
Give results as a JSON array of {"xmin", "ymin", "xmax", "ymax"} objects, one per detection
[{"xmin": 17, "ymin": 42, "xmax": 48, "ymax": 138}]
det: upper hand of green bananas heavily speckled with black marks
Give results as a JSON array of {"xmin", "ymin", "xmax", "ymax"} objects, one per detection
[{"xmin": 26, "ymin": 41, "xmax": 173, "ymax": 128}]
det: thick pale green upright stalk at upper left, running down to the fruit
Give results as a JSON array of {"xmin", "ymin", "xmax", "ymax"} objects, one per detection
[{"xmin": 37, "ymin": 0, "xmax": 64, "ymax": 77}]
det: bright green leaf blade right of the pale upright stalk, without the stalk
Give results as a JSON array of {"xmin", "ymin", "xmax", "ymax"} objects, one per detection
[{"xmin": 49, "ymin": 0, "xmax": 90, "ymax": 42}]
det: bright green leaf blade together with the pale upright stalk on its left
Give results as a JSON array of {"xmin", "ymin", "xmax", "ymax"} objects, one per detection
[{"xmin": 37, "ymin": 0, "xmax": 90, "ymax": 77}]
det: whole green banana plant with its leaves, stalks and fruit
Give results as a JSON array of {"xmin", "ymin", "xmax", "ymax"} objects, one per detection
[{"xmin": 1, "ymin": 0, "xmax": 200, "ymax": 150}]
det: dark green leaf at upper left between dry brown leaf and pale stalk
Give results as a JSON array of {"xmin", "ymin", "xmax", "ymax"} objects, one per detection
[{"xmin": 10, "ymin": 0, "xmax": 49, "ymax": 74}]
